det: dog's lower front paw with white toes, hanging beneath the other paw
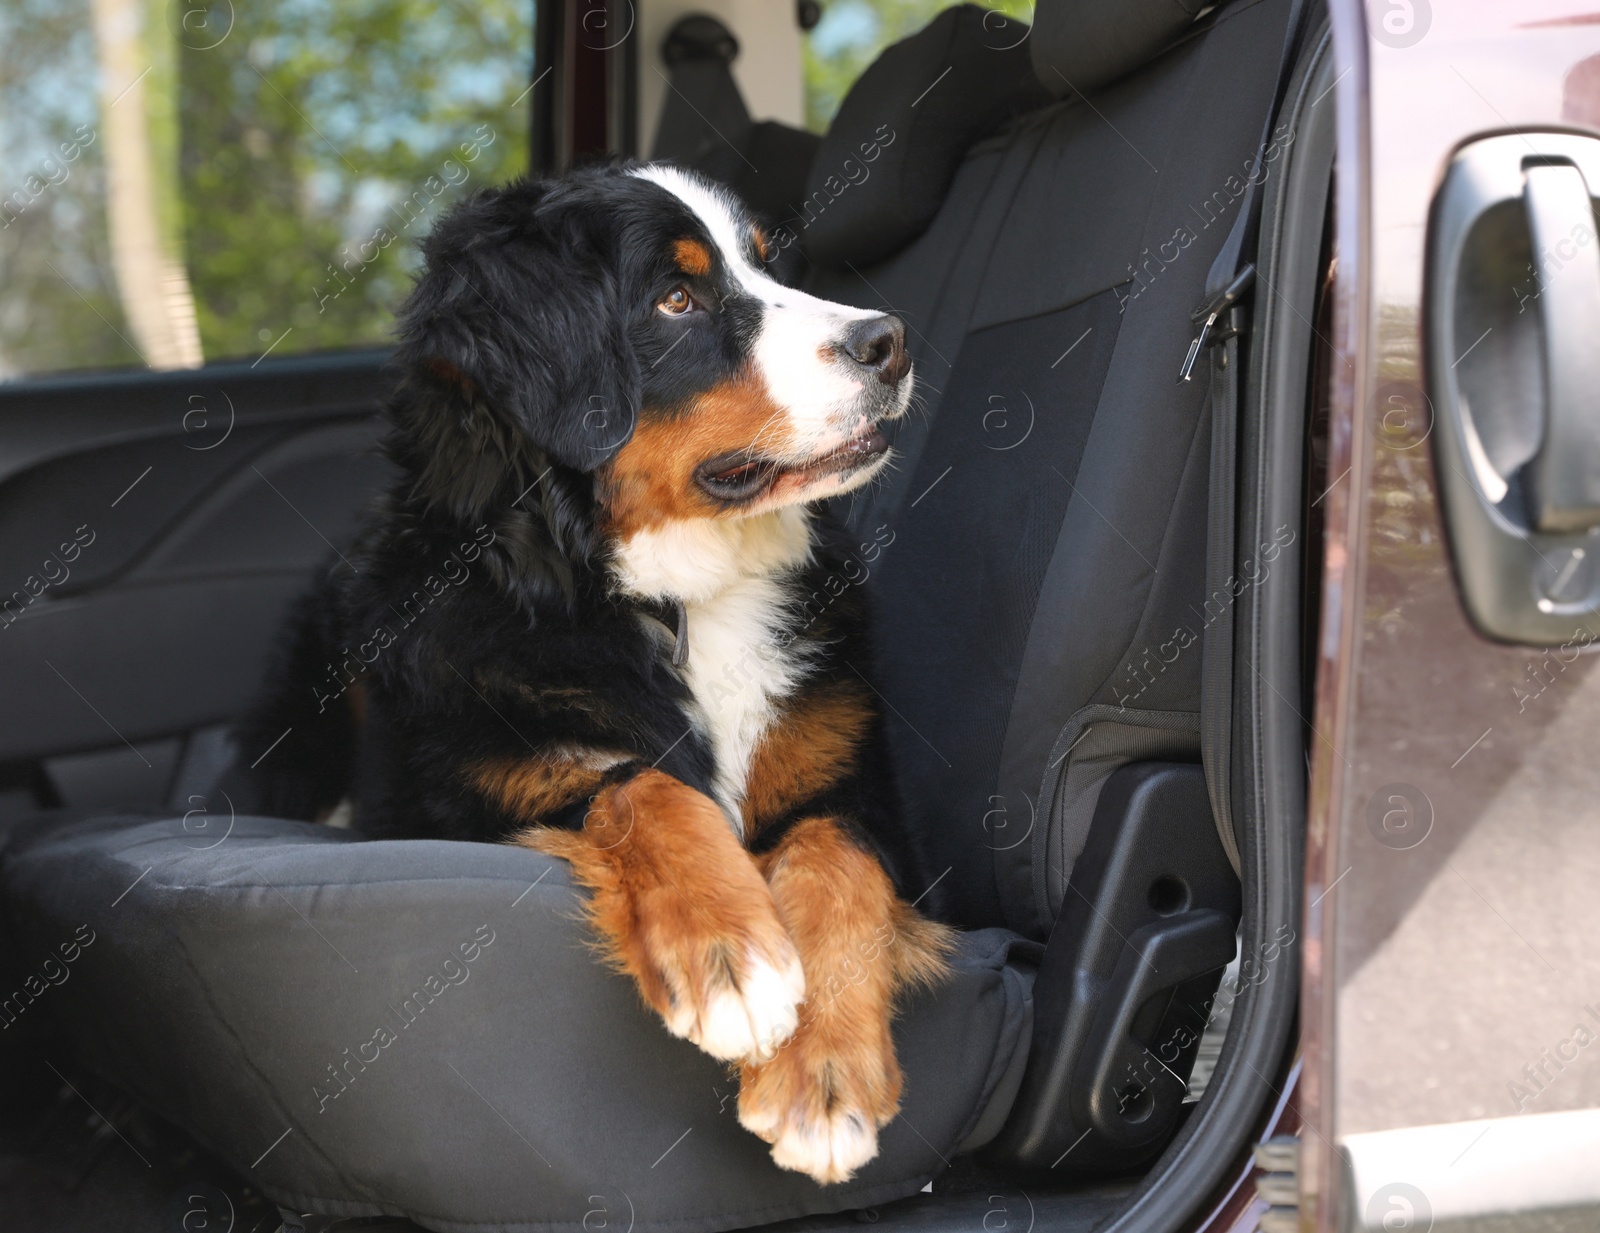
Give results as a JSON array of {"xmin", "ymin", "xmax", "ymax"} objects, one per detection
[{"xmin": 739, "ymin": 1022, "xmax": 901, "ymax": 1185}]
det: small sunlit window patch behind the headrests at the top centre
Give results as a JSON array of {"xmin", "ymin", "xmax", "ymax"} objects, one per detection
[{"xmin": 805, "ymin": 0, "xmax": 1034, "ymax": 133}]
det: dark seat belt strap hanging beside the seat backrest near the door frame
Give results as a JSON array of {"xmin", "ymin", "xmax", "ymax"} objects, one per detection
[{"xmin": 1178, "ymin": 0, "xmax": 1309, "ymax": 872}]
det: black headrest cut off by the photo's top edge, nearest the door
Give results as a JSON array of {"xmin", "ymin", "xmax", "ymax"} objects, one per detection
[{"xmin": 1029, "ymin": 0, "xmax": 1218, "ymax": 98}]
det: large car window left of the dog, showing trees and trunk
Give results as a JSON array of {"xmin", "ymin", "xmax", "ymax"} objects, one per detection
[{"xmin": 0, "ymin": 0, "xmax": 534, "ymax": 379}]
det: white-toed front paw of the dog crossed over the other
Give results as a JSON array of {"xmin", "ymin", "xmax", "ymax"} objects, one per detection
[{"xmin": 646, "ymin": 918, "xmax": 805, "ymax": 1062}]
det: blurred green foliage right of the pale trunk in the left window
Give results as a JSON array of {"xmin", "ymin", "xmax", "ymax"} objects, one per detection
[{"xmin": 179, "ymin": 0, "xmax": 533, "ymax": 358}]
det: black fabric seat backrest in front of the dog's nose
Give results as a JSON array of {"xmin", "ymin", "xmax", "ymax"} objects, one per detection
[{"xmin": 806, "ymin": 0, "xmax": 1288, "ymax": 939}]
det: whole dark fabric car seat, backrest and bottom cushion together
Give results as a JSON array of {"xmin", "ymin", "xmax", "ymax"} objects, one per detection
[{"xmin": 0, "ymin": 0, "xmax": 1286, "ymax": 1233}]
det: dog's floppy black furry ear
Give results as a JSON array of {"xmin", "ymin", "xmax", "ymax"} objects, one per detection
[{"xmin": 397, "ymin": 181, "xmax": 640, "ymax": 472}]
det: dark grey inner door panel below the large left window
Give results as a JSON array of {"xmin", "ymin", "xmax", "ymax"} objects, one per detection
[{"xmin": 0, "ymin": 353, "xmax": 389, "ymax": 804}]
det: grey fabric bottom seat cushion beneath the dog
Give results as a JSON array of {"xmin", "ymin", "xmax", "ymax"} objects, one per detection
[{"xmin": 0, "ymin": 816, "xmax": 1029, "ymax": 1233}]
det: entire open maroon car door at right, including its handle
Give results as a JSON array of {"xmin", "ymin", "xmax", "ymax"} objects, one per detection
[{"xmin": 1301, "ymin": 0, "xmax": 1600, "ymax": 1230}]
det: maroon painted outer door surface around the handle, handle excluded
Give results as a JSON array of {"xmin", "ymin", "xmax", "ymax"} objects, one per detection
[{"xmin": 1301, "ymin": 0, "xmax": 1600, "ymax": 1233}]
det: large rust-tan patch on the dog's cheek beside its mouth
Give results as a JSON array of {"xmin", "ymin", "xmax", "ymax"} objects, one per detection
[{"xmin": 597, "ymin": 369, "xmax": 794, "ymax": 541}]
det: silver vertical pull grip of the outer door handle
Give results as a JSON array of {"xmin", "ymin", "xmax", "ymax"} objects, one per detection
[{"xmin": 1522, "ymin": 163, "xmax": 1600, "ymax": 534}]
